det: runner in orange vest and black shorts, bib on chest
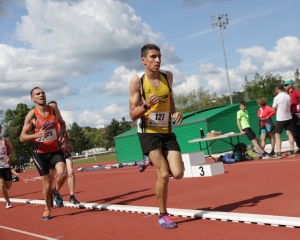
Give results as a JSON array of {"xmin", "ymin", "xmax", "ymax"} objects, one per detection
[{"xmin": 20, "ymin": 87, "xmax": 70, "ymax": 220}]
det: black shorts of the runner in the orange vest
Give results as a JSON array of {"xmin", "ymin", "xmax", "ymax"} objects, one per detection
[{"xmin": 33, "ymin": 150, "xmax": 66, "ymax": 176}]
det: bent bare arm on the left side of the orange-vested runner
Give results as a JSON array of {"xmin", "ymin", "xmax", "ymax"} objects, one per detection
[{"xmin": 20, "ymin": 111, "xmax": 47, "ymax": 142}]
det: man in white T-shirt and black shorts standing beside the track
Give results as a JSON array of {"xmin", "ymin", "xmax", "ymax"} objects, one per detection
[{"xmin": 272, "ymin": 83, "xmax": 296, "ymax": 158}]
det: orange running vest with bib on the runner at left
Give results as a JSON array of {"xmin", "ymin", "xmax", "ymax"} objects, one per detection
[{"xmin": 32, "ymin": 106, "xmax": 60, "ymax": 153}]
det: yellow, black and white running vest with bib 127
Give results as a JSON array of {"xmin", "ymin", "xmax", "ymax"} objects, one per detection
[{"xmin": 137, "ymin": 70, "xmax": 173, "ymax": 133}]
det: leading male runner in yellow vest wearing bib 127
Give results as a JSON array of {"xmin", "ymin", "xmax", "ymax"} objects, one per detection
[{"xmin": 129, "ymin": 44, "xmax": 184, "ymax": 229}]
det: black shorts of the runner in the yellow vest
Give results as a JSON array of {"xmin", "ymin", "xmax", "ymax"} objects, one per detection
[{"xmin": 138, "ymin": 133, "xmax": 180, "ymax": 155}]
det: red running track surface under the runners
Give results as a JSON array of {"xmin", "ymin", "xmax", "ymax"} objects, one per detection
[{"xmin": 0, "ymin": 156, "xmax": 300, "ymax": 240}]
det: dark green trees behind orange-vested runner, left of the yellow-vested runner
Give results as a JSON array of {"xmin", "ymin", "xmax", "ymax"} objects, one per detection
[{"xmin": 0, "ymin": 103, "xmax": 132, "ymax": 165}]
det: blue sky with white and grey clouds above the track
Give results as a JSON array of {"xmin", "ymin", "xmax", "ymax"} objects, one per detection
[{"xmin": 0, "ymin": 0, "xmax": 300, "ymax": 127}]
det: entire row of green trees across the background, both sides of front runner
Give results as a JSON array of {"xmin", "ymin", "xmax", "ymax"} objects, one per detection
[{"xmin": 0, "ymin": 68, "xmax": 300, "ymax": 164}]
